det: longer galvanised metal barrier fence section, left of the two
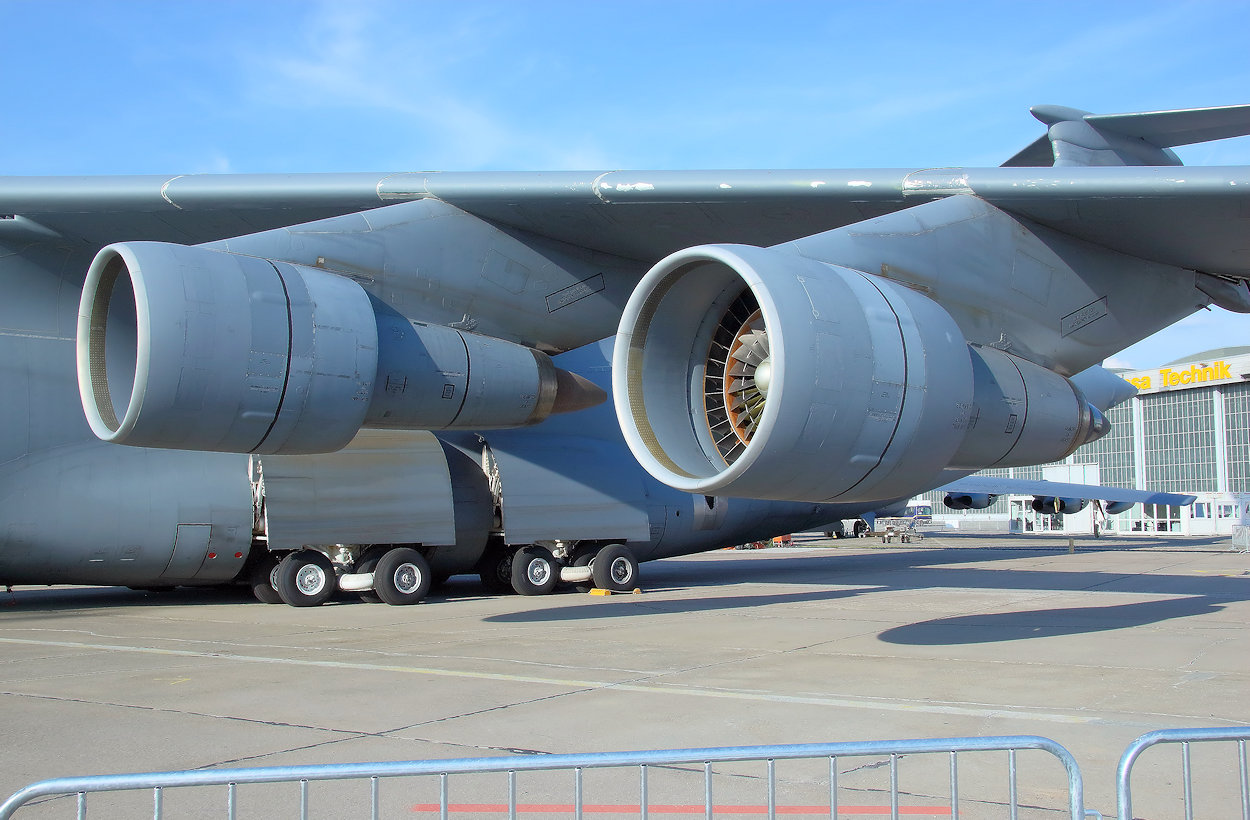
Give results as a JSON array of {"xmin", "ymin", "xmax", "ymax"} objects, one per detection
[{"xmin": 0, "ymin": 735, "xmax": 1099, "ymax": 820}]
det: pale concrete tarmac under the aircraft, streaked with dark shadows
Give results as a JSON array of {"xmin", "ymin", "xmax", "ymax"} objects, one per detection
[{"xmin": 0, "ymin": 535, "xmax": 1250, "ymax": 818}]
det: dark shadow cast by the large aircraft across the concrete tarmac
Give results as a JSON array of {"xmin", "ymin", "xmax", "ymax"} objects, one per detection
[{"xmin": 0, "ymin": 548, "xmax": 1250, "ymax": 645}]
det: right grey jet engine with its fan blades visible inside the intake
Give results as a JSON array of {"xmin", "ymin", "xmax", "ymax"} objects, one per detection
[{"xmin": 613, "ymin": 245, "xmax": 1108, "ymax": 501}]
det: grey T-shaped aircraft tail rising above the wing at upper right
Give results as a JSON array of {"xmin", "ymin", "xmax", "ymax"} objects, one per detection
[{"xmin": 1003, "ymin": 105, "xmax": 1250, "ymax": 168}]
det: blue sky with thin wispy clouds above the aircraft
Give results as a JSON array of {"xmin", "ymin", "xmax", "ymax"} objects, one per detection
[{"xmin": 0, "ymin": 0, "xmax": 1250, "ymax": 368}]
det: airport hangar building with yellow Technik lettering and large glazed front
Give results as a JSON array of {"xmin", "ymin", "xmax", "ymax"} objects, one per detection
[{"xmin": 921, "ymin": 346, "xmax": 1250, "ymax": 535}]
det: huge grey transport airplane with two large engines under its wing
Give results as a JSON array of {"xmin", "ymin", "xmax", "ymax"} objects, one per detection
[{"xmin": 0, "ymin": 106, "xmax": 1235, "ymax": 606}]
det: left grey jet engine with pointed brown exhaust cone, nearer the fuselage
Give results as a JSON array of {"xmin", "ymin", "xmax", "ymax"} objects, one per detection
[{"xmin": 78, "ymin": 243, "xmax": 605, "ymax": 454}]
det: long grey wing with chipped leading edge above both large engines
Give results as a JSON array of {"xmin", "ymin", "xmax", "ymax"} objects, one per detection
[{"xmin": 7, "ymin": 166, "xmax": 1250, "ymax": 279}]
